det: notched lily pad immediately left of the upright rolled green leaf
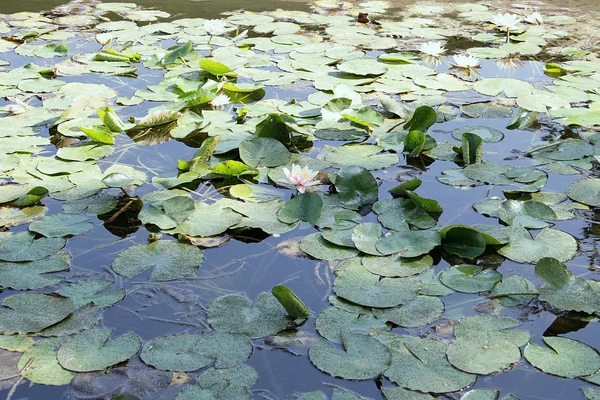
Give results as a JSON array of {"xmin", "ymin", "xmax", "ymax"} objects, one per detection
[{"xmin": 208, "ymin": 293, "xmax": 287, "ymax": 339}]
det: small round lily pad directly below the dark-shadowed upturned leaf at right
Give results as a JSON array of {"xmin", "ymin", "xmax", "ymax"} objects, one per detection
[{"xmin": 440, "ymin": 264, "xmax": 502, "ymax": 293}]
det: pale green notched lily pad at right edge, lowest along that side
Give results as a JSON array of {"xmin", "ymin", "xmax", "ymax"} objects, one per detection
[{"xmin": 524, "ymin": 336, "xmax": 600, "ymax": 378}]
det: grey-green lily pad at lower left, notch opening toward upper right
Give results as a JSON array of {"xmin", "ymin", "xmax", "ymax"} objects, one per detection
[{"xmin": 56, "ymin": 329, "xmax": 142, "ymax": 372}]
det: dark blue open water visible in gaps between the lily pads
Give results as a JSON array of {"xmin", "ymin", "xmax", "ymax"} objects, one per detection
[{"xmin": 0, "ymin": 0, "xmax": 600, "ymax": 400}]
